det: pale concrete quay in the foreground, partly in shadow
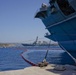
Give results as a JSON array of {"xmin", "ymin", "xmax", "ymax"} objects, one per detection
[{"xmin": 0, "ymin": 64, "xmax": 76, "ymax": 75}]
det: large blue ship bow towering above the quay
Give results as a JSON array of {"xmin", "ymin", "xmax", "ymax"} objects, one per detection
[{"xmin": 35, "ymin": 0, "xmax": 76, "ymax": 58}]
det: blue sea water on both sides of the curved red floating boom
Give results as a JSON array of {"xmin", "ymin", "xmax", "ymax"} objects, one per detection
[{"xmin": 0, "ymin": 47, "xmax": 75, "ymax": 71}]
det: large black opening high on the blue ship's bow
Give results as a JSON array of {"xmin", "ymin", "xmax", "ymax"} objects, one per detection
[{"xmin": 57, "ymin": 0, "xmax": 75, "ymax": 16}]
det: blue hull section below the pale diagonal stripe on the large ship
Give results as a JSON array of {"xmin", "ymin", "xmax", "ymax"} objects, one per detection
[{"xmin": 46, "ymin": 17, "xmax": 76, "ymax": 52}]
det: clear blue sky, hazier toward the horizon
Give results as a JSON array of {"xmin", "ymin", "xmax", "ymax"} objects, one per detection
[{"xmin": 0, "ymin": 0, "xmax": 49, "ymax": 42}]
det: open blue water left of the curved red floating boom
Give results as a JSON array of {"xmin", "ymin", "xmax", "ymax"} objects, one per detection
[{"xmin": 0, "ymin": 48, "xmax": 30, "ymax": 71}]
